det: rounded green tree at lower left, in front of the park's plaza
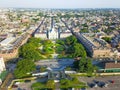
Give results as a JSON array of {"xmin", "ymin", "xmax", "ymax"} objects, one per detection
[{"xmin": 14, "ymin": 59, "xmax": 35, "ymax": 78}]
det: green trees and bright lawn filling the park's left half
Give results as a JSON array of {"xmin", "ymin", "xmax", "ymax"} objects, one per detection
[{"xmin": 19, "ymin": 37, "xmax": 54, "ymax": 61}]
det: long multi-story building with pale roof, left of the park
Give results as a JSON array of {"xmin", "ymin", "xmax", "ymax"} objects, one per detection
[{"xmin": 0, "ymin": 33, "xmax": 30, "ymax": 60}]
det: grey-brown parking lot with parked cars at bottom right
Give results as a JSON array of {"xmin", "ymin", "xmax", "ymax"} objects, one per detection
[{"xmin": 79, "ymin": 76, "xmax": 120, "ymax": 90}]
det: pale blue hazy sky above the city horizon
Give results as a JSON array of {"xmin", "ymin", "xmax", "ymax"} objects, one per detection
[{"xmin": 0, "ymin": 0, "xmax": 120, "ymax": 8}]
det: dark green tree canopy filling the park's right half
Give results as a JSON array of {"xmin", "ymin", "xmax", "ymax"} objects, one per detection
[{"xmin": 56, "ymin": 36, "xmax": 86, "ymax": 58}]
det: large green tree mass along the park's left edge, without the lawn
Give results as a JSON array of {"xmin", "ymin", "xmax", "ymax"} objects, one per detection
[{"xmin": 19, "ymin": 37, "xmax": 43, "ymax": 61}]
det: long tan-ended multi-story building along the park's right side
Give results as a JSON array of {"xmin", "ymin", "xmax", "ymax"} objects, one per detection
[{"xmin": 75, "ymin": 33, "xmax": 112, "ymax": 58}]
